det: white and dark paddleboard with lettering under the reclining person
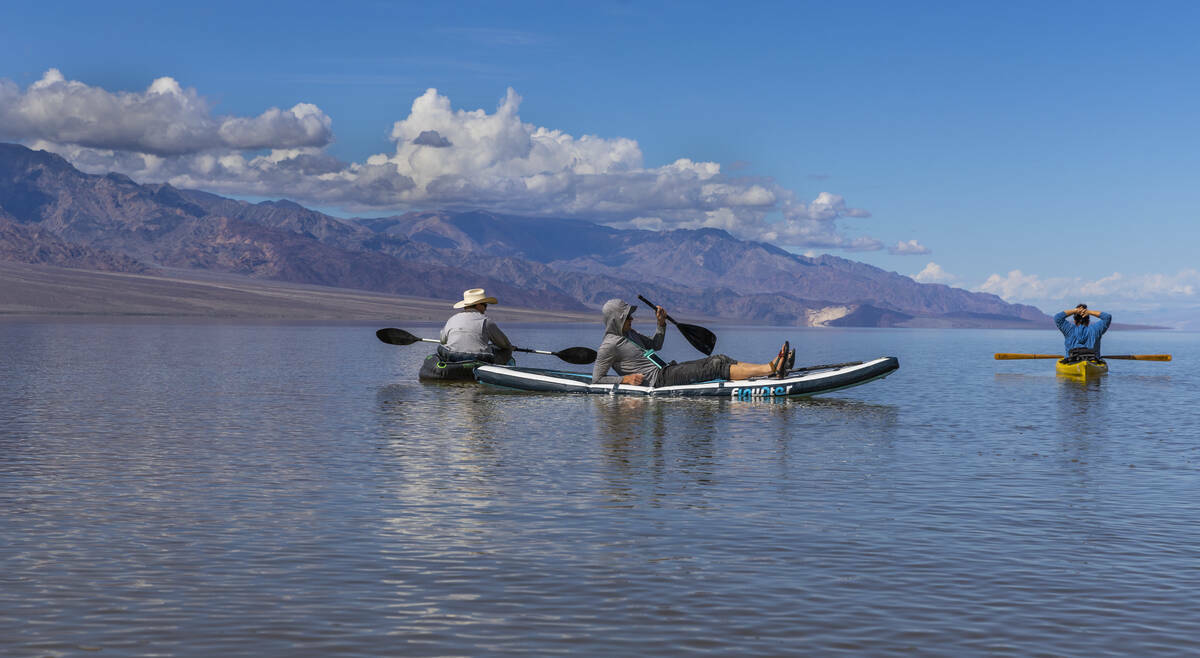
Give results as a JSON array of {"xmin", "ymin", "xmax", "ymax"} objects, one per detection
[{"xmin": 475, "ymin": 357, "xmax": 900, "ymax": 400}]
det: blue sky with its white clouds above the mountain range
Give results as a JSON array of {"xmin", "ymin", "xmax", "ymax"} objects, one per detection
[{"xmin": 0, "ymin": 1, "xmax": 1200, "ymax": 322}]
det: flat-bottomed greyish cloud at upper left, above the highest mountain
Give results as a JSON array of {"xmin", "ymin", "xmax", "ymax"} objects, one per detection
[{"xmin": 0, "ymin": 68, "xmax": 332, "ymax": 156}]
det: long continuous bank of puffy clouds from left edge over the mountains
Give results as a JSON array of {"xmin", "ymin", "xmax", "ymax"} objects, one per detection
[{"xmin": 0, "ymin": 70, "xmax": 902, "ymax": 253}]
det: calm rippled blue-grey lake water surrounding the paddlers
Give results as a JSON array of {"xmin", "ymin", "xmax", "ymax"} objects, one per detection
[{"xmin": 0, "ymin": 319, "xmax": 1200, "ymax": 656}]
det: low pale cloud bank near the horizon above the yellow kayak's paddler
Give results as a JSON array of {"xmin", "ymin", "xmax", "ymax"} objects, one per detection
[{"xmin": 977, "ymin": 269, "xmax": 1200, "ymax": 310}]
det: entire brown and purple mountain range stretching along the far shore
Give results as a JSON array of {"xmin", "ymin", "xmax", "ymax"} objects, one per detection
[{"xmin": 0, "ymin": 144, "xmax": 1048, "ymax": 327}]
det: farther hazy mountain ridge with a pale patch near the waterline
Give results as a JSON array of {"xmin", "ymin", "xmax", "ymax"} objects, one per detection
[{"xmin": 355, "ymin": 211, "xmax": 1048, "ymax": 327}]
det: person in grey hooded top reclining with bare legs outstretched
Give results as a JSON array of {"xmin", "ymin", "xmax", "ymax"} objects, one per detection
[{"xmin": 592, "ymin": 299, "xmax": 796, "ymax": 388}]
